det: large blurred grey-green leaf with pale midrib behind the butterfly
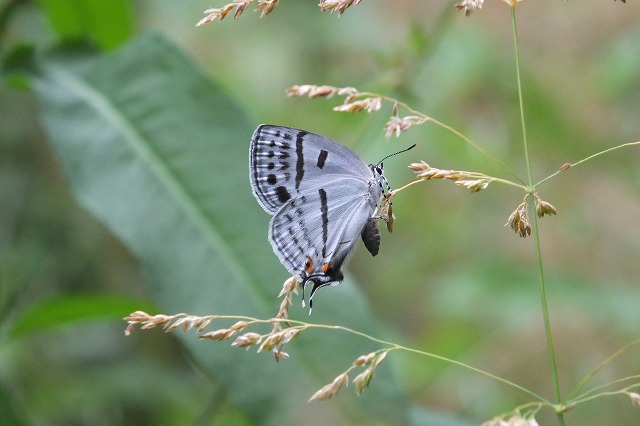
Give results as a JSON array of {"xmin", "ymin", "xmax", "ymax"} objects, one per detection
[{"xmin": 26, "ymin": 36, "xmax": 460, "ymax": 424}]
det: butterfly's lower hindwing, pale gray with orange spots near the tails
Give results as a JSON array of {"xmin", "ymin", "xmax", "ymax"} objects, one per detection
[{"xmin": 269, "ymin": 178, "xmax": 378, "ymax": 277}]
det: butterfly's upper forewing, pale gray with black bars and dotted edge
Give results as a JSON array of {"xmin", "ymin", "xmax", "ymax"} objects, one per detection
[{"xmin": 249, "ymin": 124, "xmax": 372, "ymax": 214}]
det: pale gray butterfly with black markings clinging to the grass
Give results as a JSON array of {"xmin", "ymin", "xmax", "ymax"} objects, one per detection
[{"xmin": 249, "ymin": 124, "xmax": 404, "ymax": 313}]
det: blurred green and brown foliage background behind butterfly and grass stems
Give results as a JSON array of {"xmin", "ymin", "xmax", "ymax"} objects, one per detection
[{"xmin": 0, "ymin": 0, "xmax": 640, "ymax": 425}]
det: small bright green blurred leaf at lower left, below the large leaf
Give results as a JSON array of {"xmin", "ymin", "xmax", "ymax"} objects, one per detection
[{"xmin": 10, "ymin": 296, "xmax": 152, "ymax": 337}]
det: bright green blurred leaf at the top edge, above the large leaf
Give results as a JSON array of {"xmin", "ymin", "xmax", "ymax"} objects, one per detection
[{"xmin": 38, "ymin": 0, "xmax": 133, "ymax": 49}]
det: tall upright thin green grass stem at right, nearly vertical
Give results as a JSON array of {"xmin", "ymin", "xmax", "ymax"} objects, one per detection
[{"xmin": 511, "ymin": 5, "xmax": 564, "ymax": 426}]
